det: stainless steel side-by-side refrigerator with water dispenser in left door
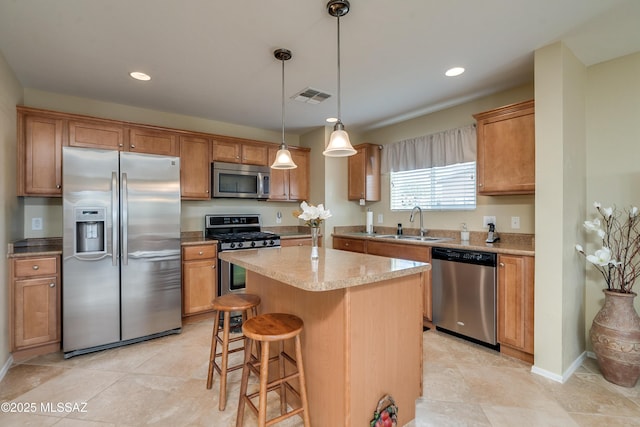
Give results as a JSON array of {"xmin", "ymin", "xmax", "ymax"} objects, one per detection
[{"xmin": 62, "ymin": 147, "xmax": 181, "ymax": 358}]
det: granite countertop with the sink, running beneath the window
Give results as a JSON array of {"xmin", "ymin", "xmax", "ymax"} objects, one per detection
[{"xmin": 332, "ymin": 227, "xmax": 535, "ymax": 256}]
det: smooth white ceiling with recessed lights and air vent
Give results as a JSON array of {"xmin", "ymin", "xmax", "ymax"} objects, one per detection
[{"xmin": 0, "ymin": 0, "xmax": 640, "ymax": 133}]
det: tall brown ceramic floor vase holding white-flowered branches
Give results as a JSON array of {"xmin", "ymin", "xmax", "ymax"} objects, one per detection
[{"xmin": 589, "ymin": 289, "xmax": 640, "ymax": 387}]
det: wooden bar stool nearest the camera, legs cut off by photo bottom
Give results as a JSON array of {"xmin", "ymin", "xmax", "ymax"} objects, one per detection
[{"xmin": 236, "ymin": 313, "xmax": 311, "ymax": 427}]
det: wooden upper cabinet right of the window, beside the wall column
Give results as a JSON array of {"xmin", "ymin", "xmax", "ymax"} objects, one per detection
[{"xmin": 473, "ymin": 100, "xmax": 535, "ymax": 195}]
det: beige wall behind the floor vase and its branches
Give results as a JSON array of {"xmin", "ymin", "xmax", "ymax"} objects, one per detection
[{"xmin": 581, "ymin": 52, "xmax": 640, "ymax": 349}]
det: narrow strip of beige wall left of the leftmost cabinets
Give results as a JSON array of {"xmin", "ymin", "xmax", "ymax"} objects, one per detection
[{"xmin": 0, "ymin": 50, "xmax": 22, "ymax": 372}]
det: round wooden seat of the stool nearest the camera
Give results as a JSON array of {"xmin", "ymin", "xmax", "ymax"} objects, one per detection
[{"xmin": 242, "ymin": 313, "xmax": 303, "ymax": 341}]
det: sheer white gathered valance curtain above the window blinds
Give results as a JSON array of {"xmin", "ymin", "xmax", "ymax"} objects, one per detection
[{"xmin": 381, "ymin": 125, "xmax": 476, "ymax": 173}]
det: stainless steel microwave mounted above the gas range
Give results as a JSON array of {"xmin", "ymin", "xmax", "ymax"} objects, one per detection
[{"xmin": 211, "ymin": 162, "xmax": 271, "ymax": 199}]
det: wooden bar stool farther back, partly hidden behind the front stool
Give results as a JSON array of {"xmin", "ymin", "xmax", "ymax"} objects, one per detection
[{"xmin": 207, "ymin": 294, "xmax": 260, "ymax": 411}]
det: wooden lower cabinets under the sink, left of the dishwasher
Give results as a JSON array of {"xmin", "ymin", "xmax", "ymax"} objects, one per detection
[{"xmin": 333, "ymin": 237, "xmax": 433, "ymax": 322}]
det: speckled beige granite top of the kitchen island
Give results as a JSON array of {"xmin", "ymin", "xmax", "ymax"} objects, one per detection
[{"xmin": 218, "ymin": 246, "xmax": 431, "ymax": 292}]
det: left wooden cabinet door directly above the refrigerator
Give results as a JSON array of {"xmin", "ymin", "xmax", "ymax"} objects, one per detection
[{"xmin": 69, "ymin": 120, "xmax": 125, "ymax": 150}]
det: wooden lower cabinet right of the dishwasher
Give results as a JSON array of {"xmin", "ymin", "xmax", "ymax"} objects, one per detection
[{"xmin": 498, "ymin": 254, "xmax": 534, "ymax": 363}]
